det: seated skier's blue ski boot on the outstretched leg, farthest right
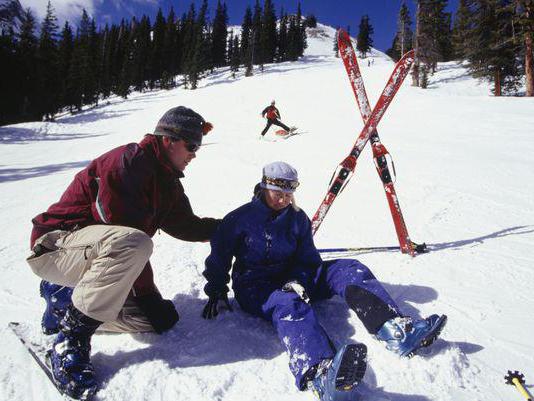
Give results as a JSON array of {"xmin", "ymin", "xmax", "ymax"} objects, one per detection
[{"xmin": 376, "ymin": 315, "xmax": 447, "ymax": 358}]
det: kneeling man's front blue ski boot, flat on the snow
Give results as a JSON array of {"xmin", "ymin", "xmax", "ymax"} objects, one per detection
[{"xmin": 47, "ymin": 304, "xmax": 102, "ymax": 400}]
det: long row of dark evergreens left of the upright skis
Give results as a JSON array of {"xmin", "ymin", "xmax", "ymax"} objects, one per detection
[{"xmin": 0, "ymin": 0, "xmax": 310, "ymax": 125}]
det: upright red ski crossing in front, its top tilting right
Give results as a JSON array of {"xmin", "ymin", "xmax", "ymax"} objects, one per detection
[{"xmin": 312, "ymin": 45, "xmax": 414, "ymax": 239}]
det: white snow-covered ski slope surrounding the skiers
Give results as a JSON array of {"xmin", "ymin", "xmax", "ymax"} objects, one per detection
[{"xmin": 0, "ymin": 27, "xmax": 534, "ymax": 401}]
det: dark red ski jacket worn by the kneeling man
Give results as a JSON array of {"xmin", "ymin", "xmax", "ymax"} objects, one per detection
[{"xmin": 30, "ymin": 135, "xmax": 219, "ymax": 295}]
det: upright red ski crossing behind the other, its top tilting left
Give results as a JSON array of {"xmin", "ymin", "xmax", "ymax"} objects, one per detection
[{"xmin": 337, "ymin": 29, "xmax": 426, "ymax": 256}]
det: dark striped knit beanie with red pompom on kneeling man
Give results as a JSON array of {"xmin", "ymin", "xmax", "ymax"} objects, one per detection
[{"xmin": 154, "ymin": 106, "xmax": 211, "ymax": 145}]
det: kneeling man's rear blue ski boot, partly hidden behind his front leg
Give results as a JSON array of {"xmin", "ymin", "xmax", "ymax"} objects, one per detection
[{"xmin": 39, "ymin": 280, "xmax": 73, "ymax": 334}]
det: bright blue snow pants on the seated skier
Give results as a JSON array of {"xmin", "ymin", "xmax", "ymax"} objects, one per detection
[{"xmin": 234, "ymin": 259, "xmax": 401, "ymax": 390}]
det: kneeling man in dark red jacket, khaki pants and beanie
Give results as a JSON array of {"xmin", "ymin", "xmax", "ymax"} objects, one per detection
[{"xmin": 27, "ymin": 106, "xmax": 219, "ymax": 399}]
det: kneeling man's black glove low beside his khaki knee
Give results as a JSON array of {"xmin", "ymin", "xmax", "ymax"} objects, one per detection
[{"xmin": 134, "ymin": 293, "xmax": 180, "ymax": 334}]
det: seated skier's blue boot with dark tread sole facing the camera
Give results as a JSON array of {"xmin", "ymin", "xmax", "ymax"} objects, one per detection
[{"xmin": 308, "ymin": 344, "xmax": 367, "ymax": 401}]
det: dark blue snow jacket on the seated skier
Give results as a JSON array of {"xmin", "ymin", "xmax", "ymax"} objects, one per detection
[{"xmin": 203, "ymin": 197, "xmax": 322, "ymax": 296}]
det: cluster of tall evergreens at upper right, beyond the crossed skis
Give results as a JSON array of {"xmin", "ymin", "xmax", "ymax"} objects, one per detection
[{"xmin": 386, "ymin": 0, "xmax": 534, "ymax": 96}]
